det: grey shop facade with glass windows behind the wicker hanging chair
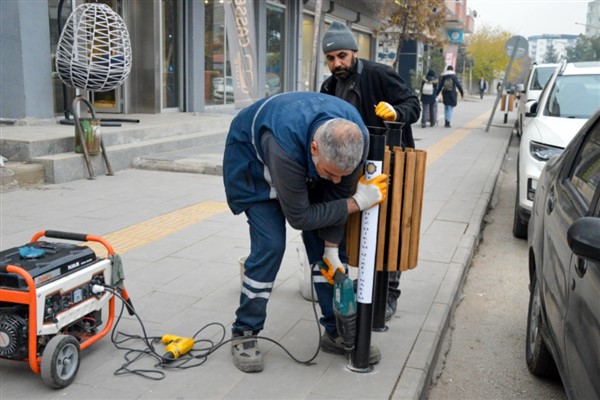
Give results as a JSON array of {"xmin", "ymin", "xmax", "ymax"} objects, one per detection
[{"xmin": 0, "ymin": 0, "xmax": 379, "ymax": 120}]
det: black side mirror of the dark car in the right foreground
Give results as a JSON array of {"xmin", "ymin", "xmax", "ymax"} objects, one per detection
[{"xmin": 567, "ymin": 217, "xmax": 600, "ymax": 262}]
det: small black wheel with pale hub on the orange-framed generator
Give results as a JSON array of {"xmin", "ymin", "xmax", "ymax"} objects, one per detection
[{"xmin": 41, "ymin": 335, "xmax": 79, "ymax": 389}]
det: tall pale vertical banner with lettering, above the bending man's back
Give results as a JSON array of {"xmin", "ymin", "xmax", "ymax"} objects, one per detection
[{"xmin": 225, "ymin": 0, "xmax": 258, "ymax": 108}]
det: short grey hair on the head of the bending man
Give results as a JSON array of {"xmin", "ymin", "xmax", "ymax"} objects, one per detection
[{"xmin": 313, "ymin": 118, "xmax": 365, "ymax": 171}]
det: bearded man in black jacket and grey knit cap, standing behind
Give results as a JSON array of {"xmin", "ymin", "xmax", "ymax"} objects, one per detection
[{"xmin": 321, "ymin": 21, "xmax": 421, "ymax": 321}]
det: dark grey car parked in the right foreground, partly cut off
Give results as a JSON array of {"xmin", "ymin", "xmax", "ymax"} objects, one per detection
[{"xmin": 525, "ymin": 106, "xmax": 600, "ymax": 400}]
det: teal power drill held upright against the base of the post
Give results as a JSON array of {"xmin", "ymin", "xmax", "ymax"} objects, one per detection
[{"xmin": 320, "ymin": 262, "xmax": 356, "ymax": 353}]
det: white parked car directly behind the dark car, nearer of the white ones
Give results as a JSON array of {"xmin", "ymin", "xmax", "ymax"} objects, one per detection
[{"xmin": 513, "ymin": 61, "xmax": 600, "ymax": 238}]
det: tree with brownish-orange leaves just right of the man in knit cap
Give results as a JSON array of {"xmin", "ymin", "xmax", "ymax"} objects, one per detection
[{"xmin": 379, "ymin": 0, "xmax": 446, "ymax": 70}]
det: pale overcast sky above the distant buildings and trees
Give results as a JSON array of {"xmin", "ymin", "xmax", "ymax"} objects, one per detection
[{"xmin": 467, "ymin": 0, "xmax": 590, "ymax": 37}]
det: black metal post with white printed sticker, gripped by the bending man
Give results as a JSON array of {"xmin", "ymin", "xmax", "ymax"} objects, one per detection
[{"xmin": 348, "ymin": 135, "xmax": 385, "ymax": 372}]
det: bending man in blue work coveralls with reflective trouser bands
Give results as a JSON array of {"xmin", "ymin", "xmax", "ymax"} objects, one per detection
[{"xmin": 223, "ymin": 92, "xmax": 388, "ymax": 372}]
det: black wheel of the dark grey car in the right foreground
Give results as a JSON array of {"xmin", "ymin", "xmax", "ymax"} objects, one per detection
[{"xmin": 525, "ymin": 274, "xmax": 556, "ymax": 376}]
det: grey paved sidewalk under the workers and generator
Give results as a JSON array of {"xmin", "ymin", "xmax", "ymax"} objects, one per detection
[{"xmin": 0, "ymin": 97, "xmax": 512, "ymax": 400}]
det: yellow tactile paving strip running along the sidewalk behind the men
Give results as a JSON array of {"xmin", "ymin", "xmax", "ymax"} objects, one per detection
[{"xmin": 86, "ymin": 112, "xmax": 489, "ymax": 256}]
